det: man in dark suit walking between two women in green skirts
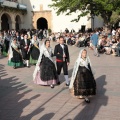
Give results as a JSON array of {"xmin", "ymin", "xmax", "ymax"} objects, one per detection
[{"xmin": 20, "ymin": 34, "xmax": 31, "ymax": 67}]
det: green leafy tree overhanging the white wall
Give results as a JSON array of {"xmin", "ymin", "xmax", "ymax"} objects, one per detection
[{"xmin": 49, "ymin": 0, "xmax": 120, "ymax": 26}]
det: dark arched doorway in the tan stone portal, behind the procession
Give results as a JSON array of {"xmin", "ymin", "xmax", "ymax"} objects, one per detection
[{"xmin": 37, "ymin": 18, "xmax": 48, "ymax": 30}]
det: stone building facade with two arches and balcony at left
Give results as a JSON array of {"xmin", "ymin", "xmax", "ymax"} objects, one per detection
[{"xmin": 0, "ymin": 0, "xmax": 27, "ymax": 30}]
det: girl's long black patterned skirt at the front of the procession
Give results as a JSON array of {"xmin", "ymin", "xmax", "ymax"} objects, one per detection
[{"xmin": 74, "ymin": 66, "xmax": 96, "ymax": 96}]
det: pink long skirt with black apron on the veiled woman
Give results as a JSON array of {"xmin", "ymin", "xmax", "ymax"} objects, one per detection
[{"xmin": 34, "ymin": 57, "xmax": 58, "ymax": 85}]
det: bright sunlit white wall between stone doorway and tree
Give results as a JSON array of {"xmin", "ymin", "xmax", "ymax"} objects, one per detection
[{"xmin": 53, "ymin": 11, "xmax": 91, "ymax": 31}]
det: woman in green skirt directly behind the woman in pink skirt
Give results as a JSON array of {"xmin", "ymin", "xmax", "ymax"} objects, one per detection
[{"xmin": 30, "ymin": 35, "xmax": 40, "ymax": 65}]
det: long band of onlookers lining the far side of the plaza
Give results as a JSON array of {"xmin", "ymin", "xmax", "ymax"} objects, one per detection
[{"xmin": 0, "ymin": 28, "xmax": 120, "ymax": 56}]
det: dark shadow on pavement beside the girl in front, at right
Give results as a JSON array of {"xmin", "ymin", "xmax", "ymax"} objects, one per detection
[{"xmin": 74, "ymin": 75, "xmax": 108, "ymax": 120}]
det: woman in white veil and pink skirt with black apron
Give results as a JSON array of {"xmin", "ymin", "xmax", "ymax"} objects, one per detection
[{"xmin": 33, "ymin": 40, "xmax": 58, "ymax": 88}]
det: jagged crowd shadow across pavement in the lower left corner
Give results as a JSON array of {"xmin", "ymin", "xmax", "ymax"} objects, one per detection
[{"xmin": 0, "ymin": 64, "xmax": 68, "ymax": 120}]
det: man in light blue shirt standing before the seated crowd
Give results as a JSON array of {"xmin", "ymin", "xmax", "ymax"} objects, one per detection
[{"xmin": 90, "ymin": 31, "xmax": 99, "ymax": 57}]
